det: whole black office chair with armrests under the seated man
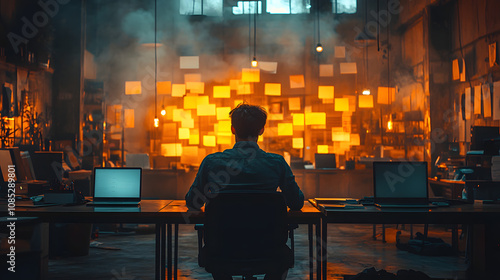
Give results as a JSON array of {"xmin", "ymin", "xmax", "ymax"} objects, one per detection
[{"xmin": 195, "ymin": 193, "xmax": 297, "ymax": 279}]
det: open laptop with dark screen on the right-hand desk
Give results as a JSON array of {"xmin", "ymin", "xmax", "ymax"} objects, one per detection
[{"xmin": 373, "ymin": 161, "xmax": 436, "ymax": 208}]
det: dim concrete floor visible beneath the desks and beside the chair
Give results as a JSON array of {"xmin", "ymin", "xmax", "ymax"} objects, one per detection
[{"xmin": 48, "ymin": 225, "xmax": 467, "ymax": 280}]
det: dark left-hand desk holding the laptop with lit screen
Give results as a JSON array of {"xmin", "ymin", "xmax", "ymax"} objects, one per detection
[{"xmin": 0, "ymin": 200, "xmax": 172, "ymax": 279}]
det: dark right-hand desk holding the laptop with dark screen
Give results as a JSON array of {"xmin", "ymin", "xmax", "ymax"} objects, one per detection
[{"xmin": 318, "ymin": 201, "xmax": 500, "ymax": 279}]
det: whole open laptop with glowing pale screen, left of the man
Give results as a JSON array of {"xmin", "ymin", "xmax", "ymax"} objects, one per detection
[{"xmin": 87, "ymin": 167, "xmax": 142, "ymax": 207}]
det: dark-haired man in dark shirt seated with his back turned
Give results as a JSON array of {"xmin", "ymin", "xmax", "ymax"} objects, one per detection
[{"xmin": 186, "ymin": 103, "xmax": 304, "ymax": 279}]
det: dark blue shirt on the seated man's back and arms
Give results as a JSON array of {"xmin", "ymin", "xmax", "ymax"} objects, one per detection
[{"xmin": 186, "ymin": 141, "xmax": 304, "ymax": 210}]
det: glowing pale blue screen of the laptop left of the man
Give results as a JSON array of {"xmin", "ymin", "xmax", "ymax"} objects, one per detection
[{"xmin": 94, "ymin": 167, "xmax": 142, "ymax": 200}]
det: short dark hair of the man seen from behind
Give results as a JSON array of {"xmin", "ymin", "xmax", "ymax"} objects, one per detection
[{"xmin": 229, "ymin": 103, "xmax": 267, "ymax": 139}]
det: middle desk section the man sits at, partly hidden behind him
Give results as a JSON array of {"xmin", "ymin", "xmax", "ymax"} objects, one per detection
[{"xmin": 160, "ymin": 200, "xmax": 323, "ymax": 279}]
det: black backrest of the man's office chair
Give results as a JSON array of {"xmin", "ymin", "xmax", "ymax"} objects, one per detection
[{"xmin": 205, "ymin": 192, "xmax": 288, "ymax": 264}]
